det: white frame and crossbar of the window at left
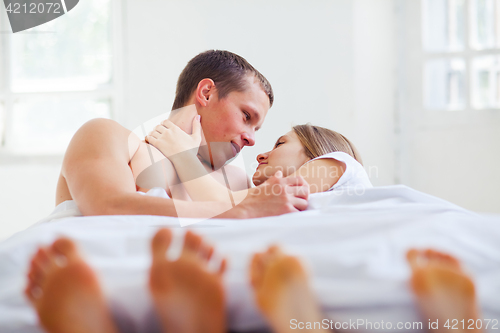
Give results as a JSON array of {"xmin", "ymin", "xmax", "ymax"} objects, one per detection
[{"xmin": 0, "ymin": 0, "xmax": 124, "ymax": 165}]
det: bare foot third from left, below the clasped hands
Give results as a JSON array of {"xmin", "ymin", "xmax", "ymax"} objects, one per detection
[{"xmin": 250, "ymin": 246, "xmax": 329, "ymax": 333}]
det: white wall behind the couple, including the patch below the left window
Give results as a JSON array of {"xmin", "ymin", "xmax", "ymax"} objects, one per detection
[{"xmin": 0, "ymin": 0, "xmax": 395, "ymax": 239}]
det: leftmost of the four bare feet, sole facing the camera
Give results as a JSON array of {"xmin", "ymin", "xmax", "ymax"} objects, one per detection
[{"xmin": 25, "ymin": 238, "xmax": 117, "ymax": 333}]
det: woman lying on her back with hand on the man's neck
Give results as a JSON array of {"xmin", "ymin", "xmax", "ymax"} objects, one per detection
[{"xmin": 146, "ymin": 116, "xmax": 372, "ymax": 204}]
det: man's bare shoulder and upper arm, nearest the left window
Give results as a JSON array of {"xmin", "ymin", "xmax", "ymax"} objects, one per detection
[{"xmin": 62, "ymin": 119, "xmax": 158, "ymax": 215}]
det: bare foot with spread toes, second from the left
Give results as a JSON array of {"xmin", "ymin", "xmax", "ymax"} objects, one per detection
[{"xmin": 149, "ymin": 229, "xmax": 226, "ymax": 333}]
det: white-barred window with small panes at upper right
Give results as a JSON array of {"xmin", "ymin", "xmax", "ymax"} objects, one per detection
[{"xmin": 422, "ymin": 0, "xmax": 500, "ymax": 110}]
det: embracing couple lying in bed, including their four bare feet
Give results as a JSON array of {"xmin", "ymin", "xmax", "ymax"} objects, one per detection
[{"xmin": 26, "ymin": 51, "xmax": 482, "ymax": 332}]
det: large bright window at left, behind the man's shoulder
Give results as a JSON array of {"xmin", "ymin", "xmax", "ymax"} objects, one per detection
[{"xmin": 0, "ymin": 0, "xmax": 119, "ymax": 155}]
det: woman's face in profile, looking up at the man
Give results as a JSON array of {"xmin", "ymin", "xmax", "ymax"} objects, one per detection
[{"xmin": 252, "ymin": 131, "xmax": 310, "ymax": 186}]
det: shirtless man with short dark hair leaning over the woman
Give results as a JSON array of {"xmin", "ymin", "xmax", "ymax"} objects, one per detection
[{"xmin": 56, "ymin": 50, "xmax": 309, "ymax": 218}]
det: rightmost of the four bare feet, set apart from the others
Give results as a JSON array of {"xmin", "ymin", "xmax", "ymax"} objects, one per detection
[{"xmin": 407, "ymin": 249, "xmax": 481, "ymax": 332}]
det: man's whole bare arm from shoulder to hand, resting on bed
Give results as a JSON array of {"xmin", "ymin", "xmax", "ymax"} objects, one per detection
[{"xmin": 62, "ymin": 119, "xmax": 308, "ymax": 218}]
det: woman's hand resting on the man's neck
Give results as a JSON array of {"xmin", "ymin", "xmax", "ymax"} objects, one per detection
[{"xmin": 146, "ymin": 115, "xmax": 201, "ymax": 157}]
